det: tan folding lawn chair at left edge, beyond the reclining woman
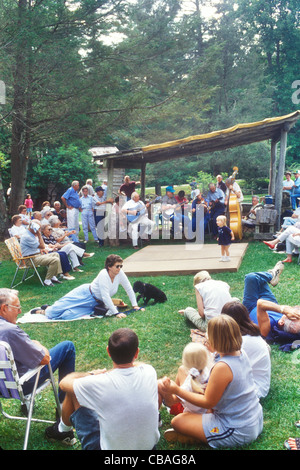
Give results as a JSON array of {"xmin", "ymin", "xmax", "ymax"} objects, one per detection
[{"xmin": 5, "ymin": 237, "xmax": 44, "ymax": 289}]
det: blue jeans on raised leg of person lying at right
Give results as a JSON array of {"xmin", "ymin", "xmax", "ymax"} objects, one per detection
[{"xmin": 243, "ymin": 272, "xmax": 278, "ymax": 313}]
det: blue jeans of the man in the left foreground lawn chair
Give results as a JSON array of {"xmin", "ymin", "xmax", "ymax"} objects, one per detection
[{"xmin": 23, "ymin": 341, "xmax": 76, "ymax": 403}]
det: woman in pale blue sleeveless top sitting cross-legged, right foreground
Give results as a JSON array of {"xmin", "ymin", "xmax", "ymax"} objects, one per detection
[{"xmin": 163, "ymin": 315, "xmax": 263, "ymax": 448}]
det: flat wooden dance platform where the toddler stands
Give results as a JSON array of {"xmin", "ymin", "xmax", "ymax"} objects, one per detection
[{"xmin": 123, "ymin": 243, "xmax": 248, "ymax": 276}]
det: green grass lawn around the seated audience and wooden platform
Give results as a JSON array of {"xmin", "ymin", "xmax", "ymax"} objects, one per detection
[{"xmin": 0, "ymin": 235, "xmax": 300, "ymax": 451}]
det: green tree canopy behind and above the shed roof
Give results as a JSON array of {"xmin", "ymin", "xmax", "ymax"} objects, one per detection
[{"xmin": 0, "ymin": 0, "xmax": 300, "ymax": 235}]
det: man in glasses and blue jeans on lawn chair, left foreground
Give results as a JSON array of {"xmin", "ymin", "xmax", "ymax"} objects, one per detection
[{"xmin": 0, "ymin": 288, "xmax": 76, "ymax": 445}]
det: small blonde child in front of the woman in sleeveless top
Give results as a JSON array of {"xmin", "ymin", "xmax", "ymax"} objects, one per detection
[{"xmin": 182, "ymin": 343, "xmax": 212, "ymax": 393}]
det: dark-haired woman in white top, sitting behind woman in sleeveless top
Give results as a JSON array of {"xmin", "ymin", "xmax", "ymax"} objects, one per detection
[{"xmin": 222, "ymin": 300, "xmax": 271, "ymax": 398}]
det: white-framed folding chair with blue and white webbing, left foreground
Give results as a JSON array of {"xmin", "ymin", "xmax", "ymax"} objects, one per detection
[{"xmin": 0, "ymin": 341, "xmax": 61, "ymax": 450}]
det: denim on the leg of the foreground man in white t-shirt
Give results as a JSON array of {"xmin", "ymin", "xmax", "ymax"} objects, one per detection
[{"xmin": 70, "ymin": 406, "xmax": 101, "ymax": 450}]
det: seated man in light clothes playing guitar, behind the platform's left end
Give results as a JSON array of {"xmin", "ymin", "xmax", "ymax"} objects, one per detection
[{"xmin": 122, "ymin": 192, "xmax": 155, "ymax": 249}]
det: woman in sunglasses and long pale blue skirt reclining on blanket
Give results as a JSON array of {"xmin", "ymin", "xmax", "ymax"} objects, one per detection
[{"xmin": 32, "ymin": 255, "xmax": 140, "ymax": 320}]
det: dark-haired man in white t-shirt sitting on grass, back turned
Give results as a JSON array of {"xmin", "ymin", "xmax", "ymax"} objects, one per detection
[{"xmin": 48, "ymin": 328, "xmax": 160, "ymax": 450}]
